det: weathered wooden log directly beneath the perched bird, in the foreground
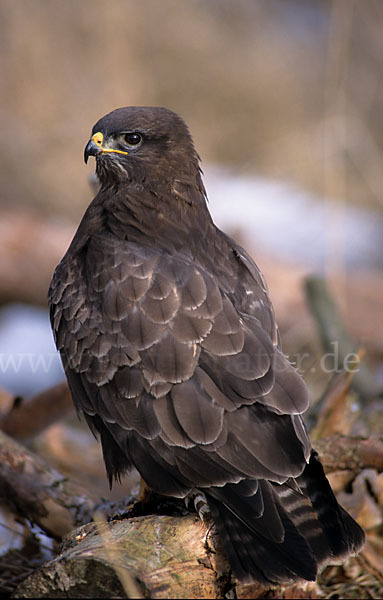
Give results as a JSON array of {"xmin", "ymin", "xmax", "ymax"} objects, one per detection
[{"xmin": 13, "ymin": 514, "xmax": 318, "ymax": 598}]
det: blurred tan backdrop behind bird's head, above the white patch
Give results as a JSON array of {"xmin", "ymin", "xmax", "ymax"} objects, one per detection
[{"xmin": 0, "ymin": 0, "xmax": 383, "ymax": 213}]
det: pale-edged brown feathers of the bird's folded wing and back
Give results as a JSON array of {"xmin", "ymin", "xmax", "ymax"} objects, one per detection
[{"xmin": 48, "ymin": 231, "xmax": 307, "ymax": 490}]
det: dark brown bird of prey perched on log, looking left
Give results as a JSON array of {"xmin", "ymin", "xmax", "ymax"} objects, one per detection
[{"xmin": 49, "ymin": 107, "xmax": 364, "ymax": 585}]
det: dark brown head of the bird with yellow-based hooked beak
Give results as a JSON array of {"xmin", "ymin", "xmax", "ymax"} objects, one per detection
[{"xmin": 84, "ymin": 106, "xmax": 199, "ymax": 190}]
